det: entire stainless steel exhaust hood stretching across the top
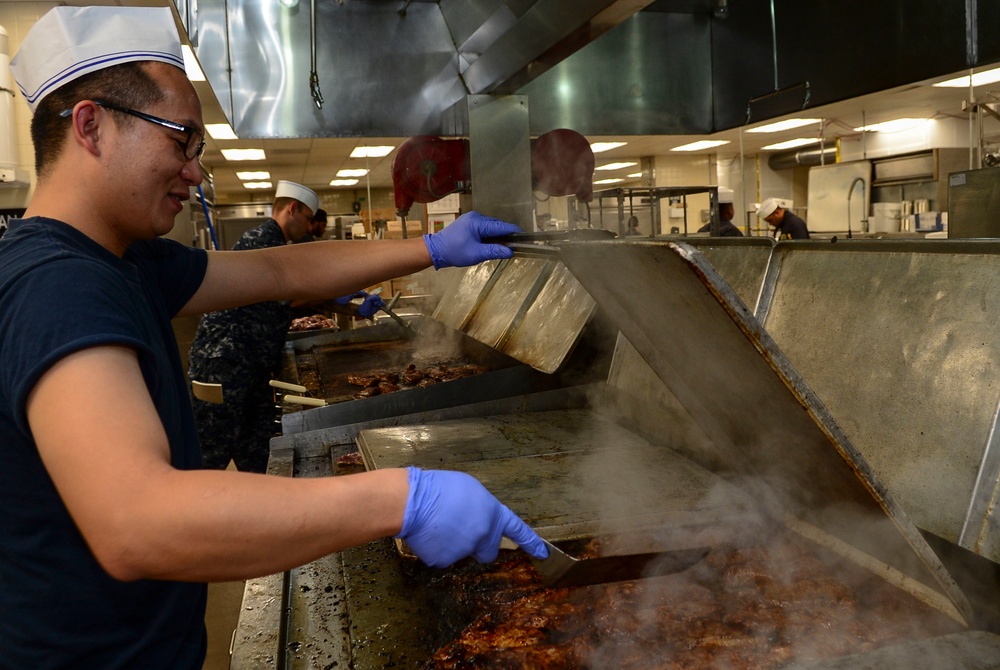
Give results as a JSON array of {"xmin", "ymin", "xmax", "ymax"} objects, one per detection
[{"xmin": 173, "ymin": 0, "xmax": 1000, "ymax": 138}]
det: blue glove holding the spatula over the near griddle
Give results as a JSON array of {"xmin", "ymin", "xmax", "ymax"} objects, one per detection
[{"xmin": 396, "ymin": 467, "xmax": 549, "ymax": 568}]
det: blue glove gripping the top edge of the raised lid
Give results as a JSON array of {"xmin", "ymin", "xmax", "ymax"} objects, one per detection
[{"xmin": 424, "ymin": 212, "xmax": 524, "ymax": 270}]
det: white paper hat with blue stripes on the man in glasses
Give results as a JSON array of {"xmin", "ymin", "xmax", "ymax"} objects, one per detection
[{"xmin": 10, "ymin": 7, "xmax": 184, "ymax": 112}]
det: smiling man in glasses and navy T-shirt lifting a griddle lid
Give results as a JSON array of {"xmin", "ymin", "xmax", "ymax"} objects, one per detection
[{"xmin": 0, "ymin": 7, "xmax": 547, "ymax": 670}]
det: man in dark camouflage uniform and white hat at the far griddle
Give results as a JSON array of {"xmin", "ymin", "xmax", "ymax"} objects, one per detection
[{"xmin": 188, "ymin": 181, "xmax": 319, "ymax": 472}]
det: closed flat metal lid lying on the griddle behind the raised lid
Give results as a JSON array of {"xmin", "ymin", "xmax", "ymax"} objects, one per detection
[{"xmin": 358, "ymin": 409, "xmax": 754, "ymax": 548}]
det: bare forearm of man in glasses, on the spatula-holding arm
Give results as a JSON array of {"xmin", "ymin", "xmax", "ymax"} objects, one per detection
[{"xmin": 100, "ymin": 470, "xmax": 408, "ymax": 581}]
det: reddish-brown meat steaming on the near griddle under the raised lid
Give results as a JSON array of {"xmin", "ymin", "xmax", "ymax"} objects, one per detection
[{"xmin": 423, "ymin": 533, "xmax": 963, "ymax": 670}]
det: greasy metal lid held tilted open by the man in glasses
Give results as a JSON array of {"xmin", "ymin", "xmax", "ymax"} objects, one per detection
[{"xmin": 559, "ymin": 241, "xmax": 972, "ymax": 621}]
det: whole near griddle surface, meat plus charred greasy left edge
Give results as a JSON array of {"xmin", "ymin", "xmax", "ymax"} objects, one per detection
[{"xmin": 335, "ymin": 455, "xmax": 963, "ymax": 670}]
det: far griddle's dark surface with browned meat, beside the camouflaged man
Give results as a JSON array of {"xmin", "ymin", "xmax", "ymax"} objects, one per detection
[{"xmin": 295, "ymin": 338, "xmax": 490, "ymax": 402}]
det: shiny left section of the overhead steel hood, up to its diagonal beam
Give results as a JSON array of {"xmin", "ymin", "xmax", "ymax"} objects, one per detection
[{"xmin": 174, "ymin": 0, "xmax": 651, "ymax": 138}]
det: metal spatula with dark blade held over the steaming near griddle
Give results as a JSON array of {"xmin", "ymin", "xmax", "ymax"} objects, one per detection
[{"xmin": 500, "ymin": 538, "xmax": 709, "ymax": 588}]
